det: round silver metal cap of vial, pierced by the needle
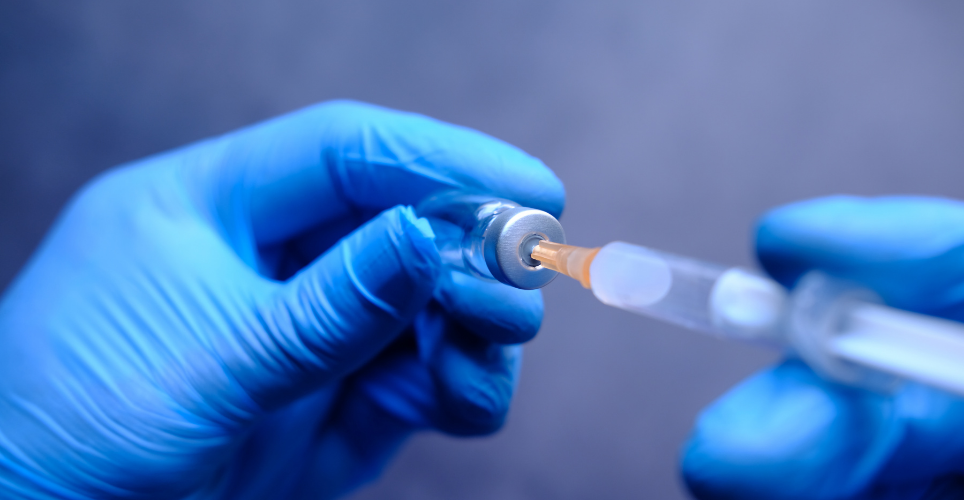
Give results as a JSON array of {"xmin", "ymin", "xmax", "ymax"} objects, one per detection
[{"xmin": 482, "ymin": 207, "xmax": 566, "ymax": 290}]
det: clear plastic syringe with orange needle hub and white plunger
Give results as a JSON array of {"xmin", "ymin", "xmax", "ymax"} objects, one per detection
[{"xmin": 531, "ymin": 241, "xmax": 964, "ymax": 396}]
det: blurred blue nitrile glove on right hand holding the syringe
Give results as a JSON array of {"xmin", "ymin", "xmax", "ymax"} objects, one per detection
[{"xmin": 683, "ymin": 197, "xmax": 964, "ymax": 500}]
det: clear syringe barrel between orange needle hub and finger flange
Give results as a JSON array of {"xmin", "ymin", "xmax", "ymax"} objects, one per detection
[{"xmin": 589, "ymin": 241, "xmax": 786, "ymax": 344}]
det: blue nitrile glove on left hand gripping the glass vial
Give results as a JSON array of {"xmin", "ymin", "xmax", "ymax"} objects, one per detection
[{"xmin": 0, "ymin": 102, "xmax": 564, "ymax": 499}]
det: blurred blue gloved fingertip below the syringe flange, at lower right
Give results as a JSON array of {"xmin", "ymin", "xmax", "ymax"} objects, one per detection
[{"xmin": 682, "ymin": 361, "xmax": 902, "ymax": 500}]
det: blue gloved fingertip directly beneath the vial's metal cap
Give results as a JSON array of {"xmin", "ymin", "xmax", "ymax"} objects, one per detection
[{"xmin": 435, "ymin": 269, "xmax": 543, "ymax": 344}]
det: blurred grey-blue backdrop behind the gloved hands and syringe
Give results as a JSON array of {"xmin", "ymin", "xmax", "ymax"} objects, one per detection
[{"xmin": 0, "ymin": 0, "xmax": 964, "ymax": 500}]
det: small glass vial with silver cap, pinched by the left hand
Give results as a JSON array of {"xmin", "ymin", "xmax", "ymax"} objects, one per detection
[{"xmin": 416, "ymin": 191, "xmax": 566, "ymax": 290}]
